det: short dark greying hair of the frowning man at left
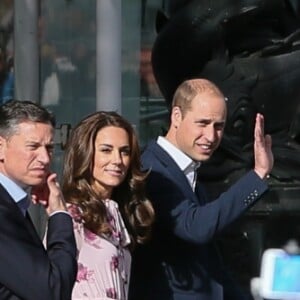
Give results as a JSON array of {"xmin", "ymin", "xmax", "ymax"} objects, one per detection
[{"xmin": 0, "ymin": 100, "xmax": 55, "ymax": 137}]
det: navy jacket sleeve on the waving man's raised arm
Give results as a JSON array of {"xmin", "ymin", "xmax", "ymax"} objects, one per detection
[{"xmin": 146, "ymin": 159, "xmax": 267, "ymax": 244}]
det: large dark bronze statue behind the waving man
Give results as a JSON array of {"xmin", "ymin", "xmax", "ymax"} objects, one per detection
[{"xmin": 152, "ymin": 0, "xmax": 300, "ymax": 186}]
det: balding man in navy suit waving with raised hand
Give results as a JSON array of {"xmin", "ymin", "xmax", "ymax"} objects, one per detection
[{"xmin": 129, "ymin": 79, "xmax": 273, "ymax": 300}]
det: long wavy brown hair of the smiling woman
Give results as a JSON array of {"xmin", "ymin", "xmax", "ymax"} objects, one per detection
[{"xmin": 62, "ymin": 111, "xmax": 154, "ymax": 245}]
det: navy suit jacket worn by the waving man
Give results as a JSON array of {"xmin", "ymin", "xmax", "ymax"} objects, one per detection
[{"xmin": 129, "ymin": 142, "xmax": 267, "ymax": 300}]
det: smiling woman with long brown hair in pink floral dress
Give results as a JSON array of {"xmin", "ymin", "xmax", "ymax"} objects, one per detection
[{"xmin": 62, "ymin": 112, "xmax": 154, "ymax": 300}]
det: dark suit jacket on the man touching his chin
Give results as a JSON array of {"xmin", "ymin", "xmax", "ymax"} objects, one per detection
[{"xmin": 0, "ymin": 184, "xmax": 77, "ymax": 300}]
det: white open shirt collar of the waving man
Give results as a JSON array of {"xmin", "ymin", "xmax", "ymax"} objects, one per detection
[{"xmin": 157, "ymin": 136, "xmax": 200, "ymax": 172}]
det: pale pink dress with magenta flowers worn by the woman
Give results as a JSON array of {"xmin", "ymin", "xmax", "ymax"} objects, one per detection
[{"xmin": 68, "ymin": 199, "xmax": 131, "ymax": 300}]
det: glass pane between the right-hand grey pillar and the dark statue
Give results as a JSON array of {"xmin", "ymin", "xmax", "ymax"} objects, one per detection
[{"xmin": 122, "ymin": 0, "xmax": 168, "ymax": 144}]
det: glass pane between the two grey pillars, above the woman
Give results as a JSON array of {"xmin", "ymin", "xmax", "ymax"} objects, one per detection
[{"xmin": 39, "ymin": 0, "xmax": 96, "ymax": 124}]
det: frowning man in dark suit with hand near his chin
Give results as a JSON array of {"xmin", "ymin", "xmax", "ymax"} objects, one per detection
[{"xmin": 0, "ymin": 101, "xmax": 77, "ymax": 300}]
